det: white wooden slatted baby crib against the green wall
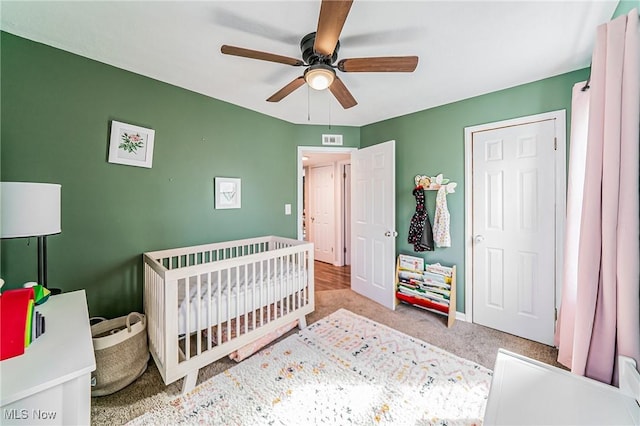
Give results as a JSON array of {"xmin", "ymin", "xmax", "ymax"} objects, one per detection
[{"xmin": 144, "ymin": 236, "xmax": 314, "ymax": 393}]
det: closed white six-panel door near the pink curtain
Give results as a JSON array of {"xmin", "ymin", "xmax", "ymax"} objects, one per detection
[{"xmin": 472, "ymin": 120, "xmax": 556, "ymax": 344}]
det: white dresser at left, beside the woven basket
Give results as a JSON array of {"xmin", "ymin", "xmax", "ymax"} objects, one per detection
[{"xmin": 0, "ymin": 290, "xmax": 96, "ymax": 425}]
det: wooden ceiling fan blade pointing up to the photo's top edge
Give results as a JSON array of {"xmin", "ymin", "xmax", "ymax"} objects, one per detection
[{"xmin": 313, "ymin": 0, "xmax": 353, "ymax": 56}]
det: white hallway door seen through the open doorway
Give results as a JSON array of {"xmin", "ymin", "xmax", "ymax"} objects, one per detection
[{"xmin": 309, "ymin": 165, "xmax": 335, "ymax": 263}]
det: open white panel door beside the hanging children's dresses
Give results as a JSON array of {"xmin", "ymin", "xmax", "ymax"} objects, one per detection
[{"xmin": 351, "ymin": 141, "xmax": 397, "ymax": 309}]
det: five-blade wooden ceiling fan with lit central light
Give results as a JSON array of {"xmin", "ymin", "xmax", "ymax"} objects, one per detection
[{"xmin": 220, "ymin": 0, "xmax": 418, "ymax": 109}]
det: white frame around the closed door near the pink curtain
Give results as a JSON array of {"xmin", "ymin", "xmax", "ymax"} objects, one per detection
[{"xmin": 464, "ymin": 109, "xmax": 567, "ymax": 322}]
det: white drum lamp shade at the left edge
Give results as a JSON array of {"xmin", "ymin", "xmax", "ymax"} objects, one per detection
[{"xmin": 0, "ymin": 182, "xmax": 62, "ymax": 238}]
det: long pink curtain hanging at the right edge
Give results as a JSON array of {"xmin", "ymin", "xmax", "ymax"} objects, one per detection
[{"xmin": 556, "ymin": 9, "xmax": 640, "ymax": 383}]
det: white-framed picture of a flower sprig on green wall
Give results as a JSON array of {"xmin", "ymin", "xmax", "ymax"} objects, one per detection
[{"xmin": 109, "ymin": 120, "xmax": 155, "ymax": 169}]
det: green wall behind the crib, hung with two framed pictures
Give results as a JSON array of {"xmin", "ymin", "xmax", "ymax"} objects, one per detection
[{"xmin": 0, "ymin": 32, "xmax": 360, "ymax": 316}]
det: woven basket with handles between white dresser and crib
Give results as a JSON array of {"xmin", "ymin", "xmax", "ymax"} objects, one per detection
[{"xmin": 91, "ymin": 312, "xmax": 149, "ymax": 396}]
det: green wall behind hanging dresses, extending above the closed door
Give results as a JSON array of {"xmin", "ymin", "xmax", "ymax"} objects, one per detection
[{"xmin": 360, "ymin": 69, "xmax": 588, "ymax": 312}]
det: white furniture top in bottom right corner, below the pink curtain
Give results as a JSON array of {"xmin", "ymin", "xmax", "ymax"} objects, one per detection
[{"xmin": 483, "ymin": 349, "xmax": 640, "ymax": 426}]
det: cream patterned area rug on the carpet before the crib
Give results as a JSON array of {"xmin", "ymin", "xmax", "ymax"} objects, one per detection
[{"xmin": 129, "ymin": 309, "xmax": 492, "ymax": 425}]
